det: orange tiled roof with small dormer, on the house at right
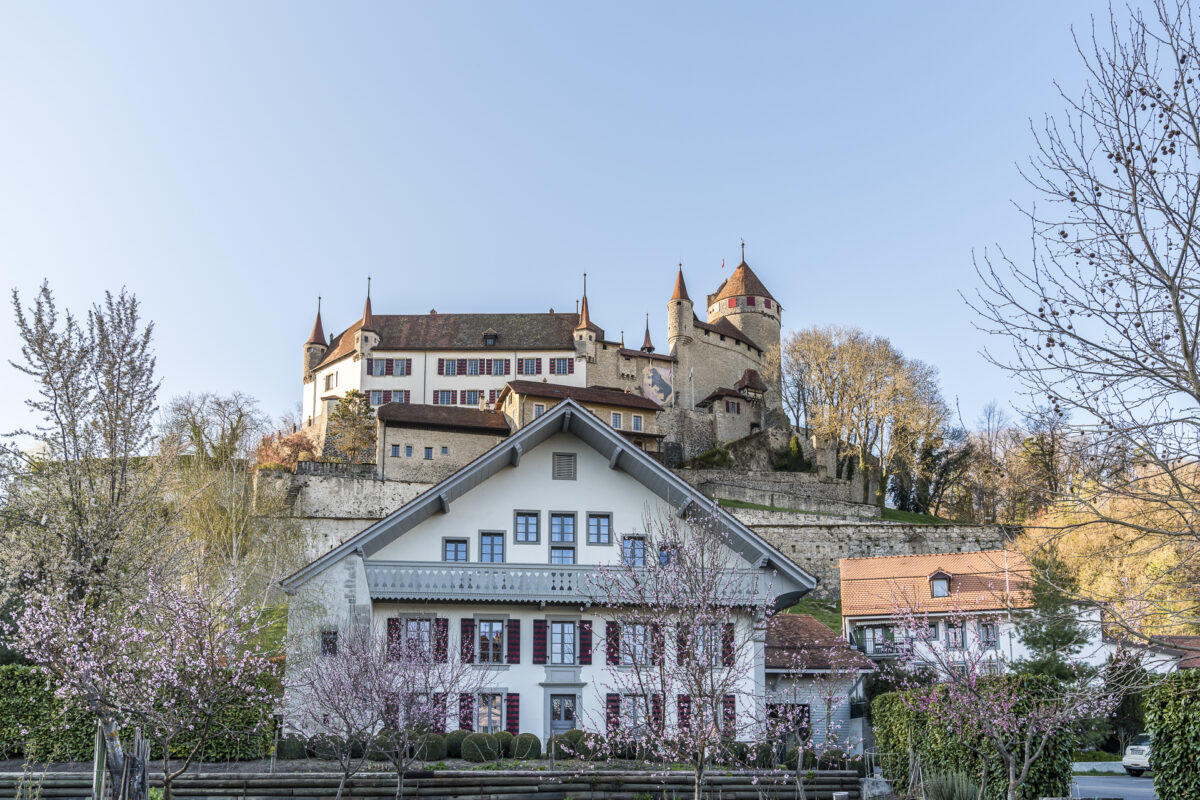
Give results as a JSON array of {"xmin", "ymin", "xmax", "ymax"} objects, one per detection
[{"xmin": 840, "ymin": 551, "xmax": 1032, "ymax": 616}]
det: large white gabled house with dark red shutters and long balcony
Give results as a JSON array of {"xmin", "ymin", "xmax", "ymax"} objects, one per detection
[{"xmin": 283, "ymin": 398, "xmax": 816, "ymax": 739}]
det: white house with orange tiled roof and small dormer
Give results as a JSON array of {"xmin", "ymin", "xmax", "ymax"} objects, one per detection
[{"xmin": 840, "ymin": 549, "xmax": 1112, "ymax": 672}]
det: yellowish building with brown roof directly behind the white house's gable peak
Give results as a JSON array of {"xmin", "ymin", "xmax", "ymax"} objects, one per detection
[{"xmin": 497, "ymin": 380, "xmax": 662, "ymax": 452}]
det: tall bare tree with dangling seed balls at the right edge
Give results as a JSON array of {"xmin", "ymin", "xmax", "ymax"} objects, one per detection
[{"xmin": 970, "ymin": 0, "xmax": 1200, "ymax": 632}]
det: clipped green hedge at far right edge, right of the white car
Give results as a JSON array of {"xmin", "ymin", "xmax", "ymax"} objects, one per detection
[{"xmin": 1146, "ymin": 669, "xmax": 1200, "ymax": 800}]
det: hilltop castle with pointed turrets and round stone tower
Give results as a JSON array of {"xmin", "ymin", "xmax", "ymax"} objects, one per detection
[{"xmin": 301, "ymin": 258, "xmax": 787, "ymax": 467}]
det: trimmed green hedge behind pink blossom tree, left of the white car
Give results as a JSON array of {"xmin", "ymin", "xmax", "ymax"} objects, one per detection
[{"xmin": 871, "ymin": 675, "xmax": 1074, "ymax": 800}]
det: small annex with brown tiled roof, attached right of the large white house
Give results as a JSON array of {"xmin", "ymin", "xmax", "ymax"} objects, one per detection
[{"xmin": 767, "ymin": 614, "xmax": 875, "ymax": 753}]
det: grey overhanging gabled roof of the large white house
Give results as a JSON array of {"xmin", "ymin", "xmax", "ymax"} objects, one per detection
[{"xmin": 281, "ymin": 398, "xmax": 817, "ymax": 608}]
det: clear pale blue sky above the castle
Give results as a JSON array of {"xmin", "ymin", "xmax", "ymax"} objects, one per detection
[{"xmin": 0, "ymin": 0, "xmax": 1132, "ymax": 429}]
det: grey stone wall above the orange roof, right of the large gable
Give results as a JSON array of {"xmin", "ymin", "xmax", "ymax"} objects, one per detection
[{"xmin": 731, "ymin": 509, "xmax": 1008, "ymax": 599}]
